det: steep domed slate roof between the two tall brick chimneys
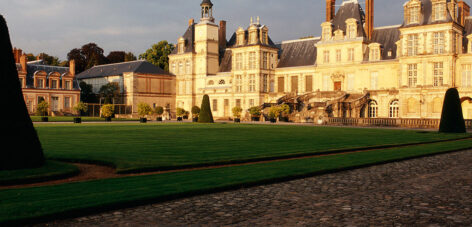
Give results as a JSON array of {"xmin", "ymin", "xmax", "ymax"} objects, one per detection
[{"xmin": 331, "ymin": 1, "xmax": 365, "ymax": 37}]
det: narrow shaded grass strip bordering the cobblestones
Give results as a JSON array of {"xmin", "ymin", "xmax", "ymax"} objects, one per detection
[{"xmin": 0, "ymin": 140, "xmax": 472, "ymax": 224}]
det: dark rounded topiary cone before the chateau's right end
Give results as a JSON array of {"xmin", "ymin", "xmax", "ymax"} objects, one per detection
[{"xmin": 439, "ymin": 88, "xmax": 466, "ymax": 133}]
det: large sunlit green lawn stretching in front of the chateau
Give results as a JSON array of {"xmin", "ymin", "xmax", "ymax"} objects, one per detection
[{"xmin": 36, "ymin": 124, "xmax": 468, "ymax": 172}]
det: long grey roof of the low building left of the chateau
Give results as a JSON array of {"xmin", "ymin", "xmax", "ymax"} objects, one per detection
[{"xmin": 76, "ymin": 60, "xmax": 171, "ymax": 79}]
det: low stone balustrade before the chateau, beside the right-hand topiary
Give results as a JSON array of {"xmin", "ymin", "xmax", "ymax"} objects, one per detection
[{"xmin": 323, "ymin": 117, "xmax": 472, "ymax": 129}]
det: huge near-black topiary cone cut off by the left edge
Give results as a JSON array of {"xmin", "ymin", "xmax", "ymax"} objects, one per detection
[{"xmin": 0, "ymin": 15, "xmax": 44, "ymax": 170}]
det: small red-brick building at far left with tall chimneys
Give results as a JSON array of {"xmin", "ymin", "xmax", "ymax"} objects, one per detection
[{"xmin": 13, "ymin": 48, "xmax": 80, "ymax": 115}]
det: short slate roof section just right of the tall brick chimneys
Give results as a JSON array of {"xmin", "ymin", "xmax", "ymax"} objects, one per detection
[{"xmin": 371, "ymin": 25, "xmax": 400, "ymax": 60}]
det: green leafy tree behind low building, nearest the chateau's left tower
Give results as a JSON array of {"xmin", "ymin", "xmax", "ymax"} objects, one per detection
[{"xmin": 139, "ymin": 40, "xmax": 174, "ymax": 72}]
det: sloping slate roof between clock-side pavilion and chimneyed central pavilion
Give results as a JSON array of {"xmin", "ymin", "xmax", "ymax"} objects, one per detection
[{"xmin": 277, "ymin": 38, "xmax": 320, "ymax": 68}]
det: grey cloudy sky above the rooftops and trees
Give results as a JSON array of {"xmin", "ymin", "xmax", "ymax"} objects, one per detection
[{"xmin": 0, "ymin": 0, "xmax": 458, "ymax": 60}]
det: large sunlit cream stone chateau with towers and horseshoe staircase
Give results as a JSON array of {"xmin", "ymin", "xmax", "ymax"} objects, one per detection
[{"xmin": 169, "ymin": 0, "xmax": 472, "ymax": 121}]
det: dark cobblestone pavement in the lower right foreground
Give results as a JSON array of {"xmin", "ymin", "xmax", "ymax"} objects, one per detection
[{"xmin": 39, "ymin": 151, "xmax": 472, "ymax": 226}]
